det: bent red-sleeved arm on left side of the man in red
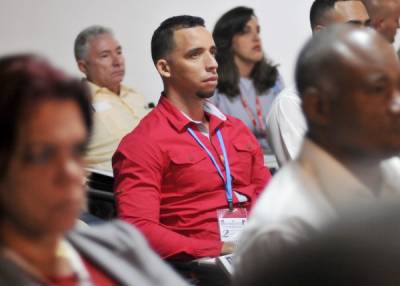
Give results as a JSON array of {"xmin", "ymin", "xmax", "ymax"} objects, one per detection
[{"xmin": 113, "ymin": 142, "xmax": 223, "ymax": 258}]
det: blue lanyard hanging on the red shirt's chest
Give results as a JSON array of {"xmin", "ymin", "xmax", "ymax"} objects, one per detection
[{"xmin": 187, "ymin": 127, "xmax": 233, "ymax": 210}]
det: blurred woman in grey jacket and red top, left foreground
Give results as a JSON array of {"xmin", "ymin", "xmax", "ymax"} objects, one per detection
[{"xmin": 0, "ymin": 55, "xmax": 186, "ymax": 286}]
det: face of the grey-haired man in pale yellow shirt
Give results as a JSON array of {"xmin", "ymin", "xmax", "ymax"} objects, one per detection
[{"xmin": 78, "ymin": 34, "xmax": 125, "ymax": 91}]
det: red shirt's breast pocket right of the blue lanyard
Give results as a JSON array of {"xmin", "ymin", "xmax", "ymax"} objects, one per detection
[{"xmin": 230, "ymin": 141, "xmax": 256, "ymax": 185}]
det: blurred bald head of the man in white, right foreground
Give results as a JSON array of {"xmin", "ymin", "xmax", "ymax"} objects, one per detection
[{"xmin": 296, "ymin": 25, "xmax": 400, "ymax": 159}]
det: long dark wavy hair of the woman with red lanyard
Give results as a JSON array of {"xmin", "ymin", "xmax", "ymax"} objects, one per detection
[{"xmin": 213, "ymin": 7, "xmax": 278, "ymax": 98}]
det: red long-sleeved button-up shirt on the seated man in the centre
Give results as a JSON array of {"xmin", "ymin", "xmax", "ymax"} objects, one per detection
[{"xmin": 113, "ymin": 96, "xmax": 271, "ymax": 259}]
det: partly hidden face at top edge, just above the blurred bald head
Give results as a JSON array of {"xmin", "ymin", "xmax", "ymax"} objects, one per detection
[{"xmin": 328, "ymin": 1, "xmax": 369, "ymax": 26}]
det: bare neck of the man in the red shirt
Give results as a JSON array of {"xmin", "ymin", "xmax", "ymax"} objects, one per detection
[{"xmin": 165, "ymin": 88, "xmax": 207, "ymax": 122}]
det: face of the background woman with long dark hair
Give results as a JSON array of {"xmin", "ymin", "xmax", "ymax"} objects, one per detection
[{"xmin": 232, "ymin": 16, "xmax": 264, "ymax": 64}]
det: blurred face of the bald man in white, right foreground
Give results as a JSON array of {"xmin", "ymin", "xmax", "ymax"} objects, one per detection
[{"xmin": 331, "ymin": 36, "xmax": 400, "ymax": 157}]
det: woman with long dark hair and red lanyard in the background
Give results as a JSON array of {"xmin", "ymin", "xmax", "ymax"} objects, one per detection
[{"xmin": 213, "ymin": 7, "xmax": 283, "ymax": 153}]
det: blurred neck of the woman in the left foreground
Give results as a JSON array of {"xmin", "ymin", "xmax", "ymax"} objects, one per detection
[{"xmin": 0, "ymin": 222, "xmax": 62, "ymax": 276}]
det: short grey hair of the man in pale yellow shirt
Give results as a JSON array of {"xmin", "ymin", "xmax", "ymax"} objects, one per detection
[{"xmin": 74, "ymin": 25, "xmax": 113, "ymax": 61}]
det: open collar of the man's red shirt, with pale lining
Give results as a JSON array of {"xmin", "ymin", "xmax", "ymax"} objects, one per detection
[{"xmin": 158, "ymin": 94, "xmax": 228, "ymax": 133}]
